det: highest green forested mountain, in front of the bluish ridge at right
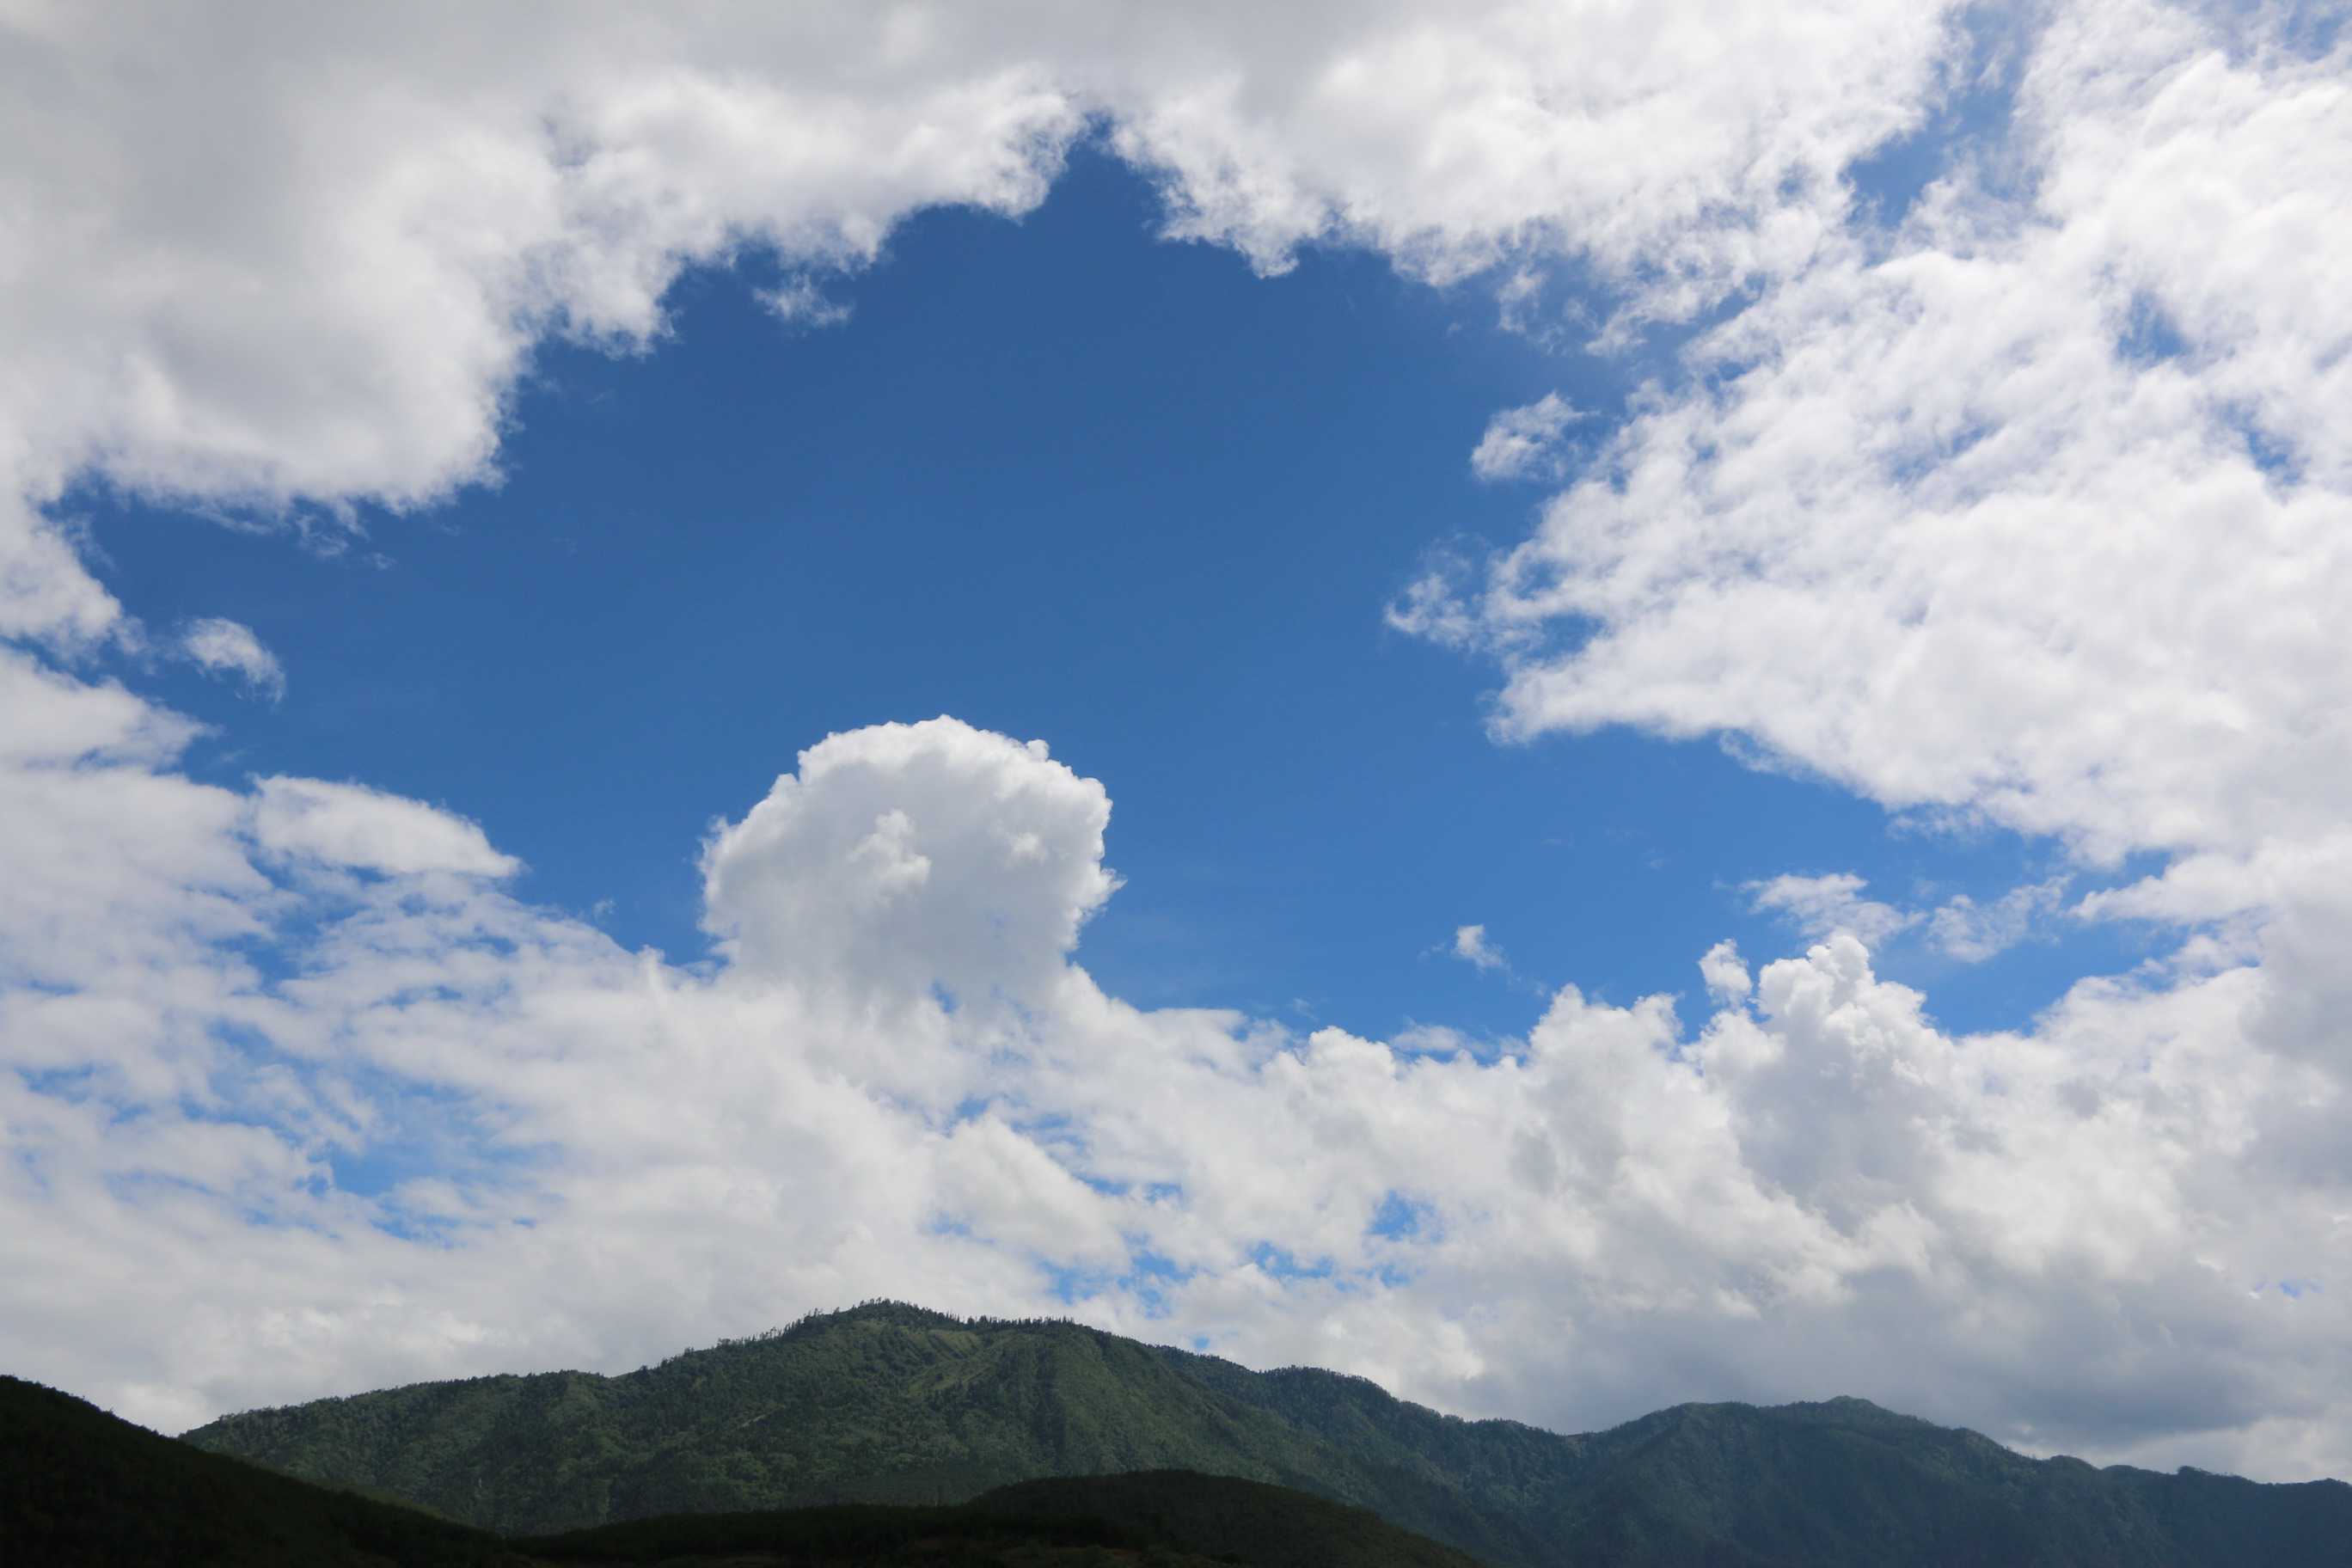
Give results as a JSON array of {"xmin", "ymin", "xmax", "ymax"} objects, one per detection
[{"xmin": 188, "ymin": 1305, "xmax": 1411, "ymax": 1533}]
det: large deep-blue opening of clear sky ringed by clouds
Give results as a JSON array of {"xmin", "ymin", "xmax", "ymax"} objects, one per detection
[{"xmin": 66, "ymin": 155, "xmax": 2183, "ymax": 1039}]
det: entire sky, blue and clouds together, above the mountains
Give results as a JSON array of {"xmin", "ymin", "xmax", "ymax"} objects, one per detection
[{"xmin": 0, "ymin": 0, "xmax": 2352, "ymax": 1479}]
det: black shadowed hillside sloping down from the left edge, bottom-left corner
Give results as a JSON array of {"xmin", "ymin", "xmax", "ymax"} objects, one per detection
[{"xmin": 0, "ymin": 1377, "xmax": 524, "ymax": 1568}]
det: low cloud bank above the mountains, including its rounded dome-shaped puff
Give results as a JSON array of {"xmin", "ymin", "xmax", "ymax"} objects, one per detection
[{"xmin": 0, "ymin": 705, "xmax": 2345, "ymax": 1495}]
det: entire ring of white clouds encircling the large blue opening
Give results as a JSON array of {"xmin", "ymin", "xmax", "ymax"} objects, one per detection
[{"xmin": 0, "ymin": 0, "xmax": 2352, "ymax": 1476}]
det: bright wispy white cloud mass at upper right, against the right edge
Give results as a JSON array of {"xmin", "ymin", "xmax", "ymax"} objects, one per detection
[{"xmin": 1420, "ymin": 3, "xmax": 2352, "ymax": 884}]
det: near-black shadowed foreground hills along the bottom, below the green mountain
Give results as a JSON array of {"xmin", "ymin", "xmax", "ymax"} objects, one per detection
[{"xmin": 0, "ymin": 1377, "xmax": 1439, "ymax": 1568}]
